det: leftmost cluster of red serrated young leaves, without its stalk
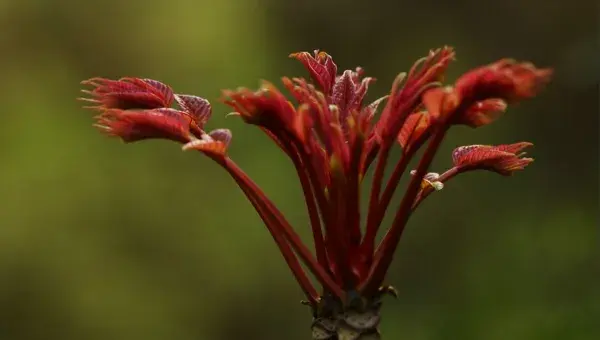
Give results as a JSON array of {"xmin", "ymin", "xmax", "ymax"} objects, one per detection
[{"xmin": 79, "ymin": 78, "xmax": 218, "ymax": 147}]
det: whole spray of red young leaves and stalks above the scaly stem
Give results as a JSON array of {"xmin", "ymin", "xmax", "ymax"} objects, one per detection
[{"xmin": 83, "ymin": 47, "xmax": 552, "ymax": 302}]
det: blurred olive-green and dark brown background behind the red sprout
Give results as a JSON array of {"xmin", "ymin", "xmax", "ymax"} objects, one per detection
[{"xmin": 0, "ymin": 0, "xmax": 600, "ymax": 340}]
